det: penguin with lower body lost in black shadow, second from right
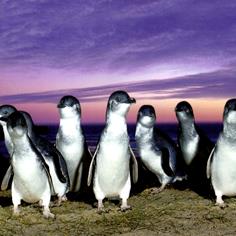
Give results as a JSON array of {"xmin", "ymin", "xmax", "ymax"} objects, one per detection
[{"xmin": 175, "ymin": 101, "xmax": 214, "ymax": 195}]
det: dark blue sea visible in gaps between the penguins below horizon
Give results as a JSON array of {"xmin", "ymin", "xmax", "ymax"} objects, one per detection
[{"xmin": 0, "ymin": 123, "xmax": 222, "ymax": 158}]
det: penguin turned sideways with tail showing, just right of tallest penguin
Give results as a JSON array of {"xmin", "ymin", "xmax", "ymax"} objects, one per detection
[{"xmin": 135, "ymin": 105, "xmax": 184, "ymax": 193}]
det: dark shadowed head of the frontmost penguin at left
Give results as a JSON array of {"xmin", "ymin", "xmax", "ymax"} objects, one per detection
[{"xmin": 7, "ymin": 111, "xmax": 28, "ymax": 138}]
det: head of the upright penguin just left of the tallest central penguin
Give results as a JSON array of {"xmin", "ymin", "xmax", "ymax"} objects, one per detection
[{"xmin": 57, "ymin": 95, "xmax": 81, "ymax": 118}]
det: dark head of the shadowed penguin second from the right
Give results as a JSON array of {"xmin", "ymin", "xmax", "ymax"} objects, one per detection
[{"xmin": 175, "ymin": 101, "xmax": 194, "ymax": 121}]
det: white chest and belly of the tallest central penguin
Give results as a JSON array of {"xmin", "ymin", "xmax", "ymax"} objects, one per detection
[{"xmin": 95, "ymin": 117, "xmax": 130, "ymax": 193}]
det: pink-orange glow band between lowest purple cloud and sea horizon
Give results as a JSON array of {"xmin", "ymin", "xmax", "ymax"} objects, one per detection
[{"xmin": 11, "ymin": 99, "xmax": 226, "ymax": 124}]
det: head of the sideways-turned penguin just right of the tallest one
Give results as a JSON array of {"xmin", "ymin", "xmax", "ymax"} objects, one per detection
[{"xmin": 137, "ymin": 105, "xmax": 156, "ymax": 128}]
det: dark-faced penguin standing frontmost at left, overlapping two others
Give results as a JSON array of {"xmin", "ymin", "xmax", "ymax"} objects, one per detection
[{"xmin": 7, "ymin": 111, "xmax": 55, "ymax": 218}]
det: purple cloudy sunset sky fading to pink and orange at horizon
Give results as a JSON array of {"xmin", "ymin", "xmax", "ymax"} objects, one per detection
[{"xmin": 0, "ymin": 0, "xmax": 236, "ymax": 123}]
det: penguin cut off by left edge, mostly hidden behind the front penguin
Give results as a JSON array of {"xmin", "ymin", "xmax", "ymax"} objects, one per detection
[{"xmin": 0, "ymin": 105, "xmax": 16, "ymax": 157}]
